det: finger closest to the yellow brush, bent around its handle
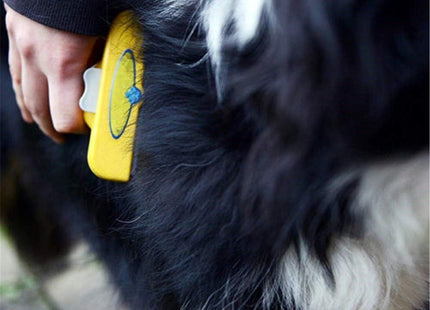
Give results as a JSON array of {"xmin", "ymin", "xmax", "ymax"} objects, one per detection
[{"xmin": 48, "ymin": 73, "xmax": 88, "ymax": 133}]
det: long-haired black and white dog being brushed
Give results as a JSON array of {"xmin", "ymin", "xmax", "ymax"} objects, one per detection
[{"xmin": 1, "ymin": 0, "xmax": 429, "ymax": 310}]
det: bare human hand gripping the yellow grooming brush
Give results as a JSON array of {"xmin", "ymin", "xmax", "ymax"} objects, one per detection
[{"xmin": 5, "ymin": 5, "xmax": 97, "ymax": 143}]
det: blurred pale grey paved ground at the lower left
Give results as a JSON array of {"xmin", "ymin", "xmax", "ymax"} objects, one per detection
[{"xmin": 0, "ymin": 233, "xmax": 125, "ymax": 310}]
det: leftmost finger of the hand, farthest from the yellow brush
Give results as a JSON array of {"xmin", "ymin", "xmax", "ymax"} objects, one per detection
[{"xmin": 9, "ymin": 21, "xmax": 33, "ymax": 123}]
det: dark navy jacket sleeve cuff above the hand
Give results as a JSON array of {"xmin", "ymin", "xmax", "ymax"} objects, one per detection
[{"xmin": 4, "ymin": 0, "xmax": 120, "ymax": 36}]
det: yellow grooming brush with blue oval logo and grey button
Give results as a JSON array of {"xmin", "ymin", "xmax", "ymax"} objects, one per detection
[{"xmin": 79, "ymin": 11, "xmax": 143, "ymax": 182}]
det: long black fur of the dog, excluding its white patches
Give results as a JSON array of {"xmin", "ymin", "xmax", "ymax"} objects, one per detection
[{"xmin": 1, "ymin": 0, "xmax": 429, "ymax": 310}]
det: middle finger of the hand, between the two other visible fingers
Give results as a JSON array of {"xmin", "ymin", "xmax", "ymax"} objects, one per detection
[{"xmin": 21, "ymin": 59, "xmax": 64, "ymax": 143}]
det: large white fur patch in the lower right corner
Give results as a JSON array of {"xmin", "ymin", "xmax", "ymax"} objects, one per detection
[{"xmin": 265, "ymin": 154, "xmax": 429, "ymax": 310}]
